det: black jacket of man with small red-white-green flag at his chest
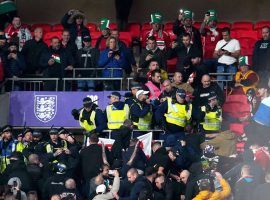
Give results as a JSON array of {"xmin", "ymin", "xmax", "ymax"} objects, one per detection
[{"xmin": 40, "ymin": 48, "xmax": 75, "ymax": 78}]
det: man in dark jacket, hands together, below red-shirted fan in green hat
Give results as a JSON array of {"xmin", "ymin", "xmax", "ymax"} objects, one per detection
[{"xmin": 139, "ymin": 36, "xmax": 167, "ymax": 69}]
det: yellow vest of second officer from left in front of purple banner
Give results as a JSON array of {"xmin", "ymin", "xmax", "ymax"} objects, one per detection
[{"xmin": 106, "ymin": 104, "xmax": 129, "ymax": 129}]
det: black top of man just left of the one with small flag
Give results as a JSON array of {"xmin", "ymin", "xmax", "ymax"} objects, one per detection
[{"xmin": 21, "ymin": 39, "xmax": 48, "ymax": 74}]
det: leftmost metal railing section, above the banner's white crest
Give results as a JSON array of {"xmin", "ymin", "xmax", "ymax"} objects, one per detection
[{"xmin": 5, "ymin": 78, "xmax": 60, "ymax": 91}]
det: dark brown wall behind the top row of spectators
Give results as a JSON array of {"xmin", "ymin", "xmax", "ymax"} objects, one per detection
[{"xmin": 16, "ymin": 0, "xmax": 270, "ymax": 23}]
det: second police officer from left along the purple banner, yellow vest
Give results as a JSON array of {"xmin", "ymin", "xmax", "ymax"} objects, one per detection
[{"xmin": 105, "ymin": 92, "xmax": 129, "ymax": 130}]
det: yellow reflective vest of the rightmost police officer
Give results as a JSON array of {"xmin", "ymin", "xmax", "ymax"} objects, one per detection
[{"xmin": 201, "ymin": 106, "xmax": 222, "ymax": 131}]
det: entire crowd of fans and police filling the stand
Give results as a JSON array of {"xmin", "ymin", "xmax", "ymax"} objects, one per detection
[{"xmin": 0, "ymin": 5, "xmax": 270, "ymax": 200}]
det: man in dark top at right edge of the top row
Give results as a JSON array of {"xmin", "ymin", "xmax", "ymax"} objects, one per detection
[{"xmin": 252, "ymin": 26, "xmax": 270, "ymax": 76}]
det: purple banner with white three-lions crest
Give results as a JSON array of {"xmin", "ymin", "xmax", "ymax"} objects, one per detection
[{"xmin": 9, "ymin": 91, "xmax": 125, "ymax": 127}]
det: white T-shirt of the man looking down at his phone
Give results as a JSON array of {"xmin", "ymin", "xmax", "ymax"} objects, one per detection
[{"xmin": 215, "ymin": 39, "xmax": 240, "ymax": 65}]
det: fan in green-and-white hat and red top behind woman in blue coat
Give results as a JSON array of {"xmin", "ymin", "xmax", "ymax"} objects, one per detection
[{"xmin": 95, "ymin": 18, "xmax": 111, "ymax": 51}]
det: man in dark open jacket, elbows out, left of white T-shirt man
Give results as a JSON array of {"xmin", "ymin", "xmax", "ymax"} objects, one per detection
[{"xmin": 167, "ymin": 32, "xmax": 202, "ymax": 71}]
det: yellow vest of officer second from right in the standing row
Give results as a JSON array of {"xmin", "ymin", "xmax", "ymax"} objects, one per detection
[{"xmin": 164, "ymin": 98, "xmax": 192, "ymax": 127}]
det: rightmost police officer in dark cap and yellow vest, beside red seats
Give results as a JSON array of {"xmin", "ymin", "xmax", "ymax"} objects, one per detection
[{"xmin": 201, "ymin": 92, "xmax": 222, "ymax": 134}]
